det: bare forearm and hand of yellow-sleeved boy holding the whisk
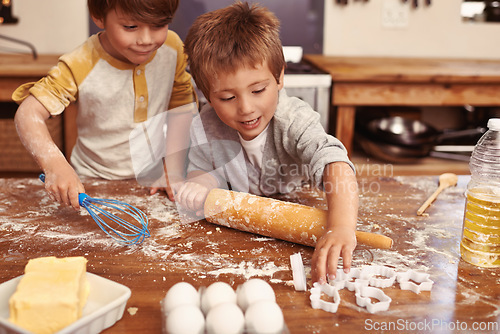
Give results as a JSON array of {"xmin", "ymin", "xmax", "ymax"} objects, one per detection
[{"xmin": 14, "ymin": 95, "xmax": 85, "ymax": 210}]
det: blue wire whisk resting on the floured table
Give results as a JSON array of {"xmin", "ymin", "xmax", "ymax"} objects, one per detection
[{"xmin": 40, "ymin": 174, "xmax": 151, "ymax": 245}]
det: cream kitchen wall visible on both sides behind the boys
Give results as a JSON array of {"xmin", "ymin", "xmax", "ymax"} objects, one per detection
[{"xmin": 0, "ymin": 0, "xmax": 500, "ymax": 59}]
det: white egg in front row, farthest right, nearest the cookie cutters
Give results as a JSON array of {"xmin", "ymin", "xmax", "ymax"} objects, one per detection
[{"xmin": 245, "ymin": 300, "xmax": 285, "ymax": 334}]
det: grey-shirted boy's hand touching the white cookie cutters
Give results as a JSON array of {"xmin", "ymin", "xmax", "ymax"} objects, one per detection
[{"xmin": 311, "ymin": 226, "xmax": 356, "ymax": 284}]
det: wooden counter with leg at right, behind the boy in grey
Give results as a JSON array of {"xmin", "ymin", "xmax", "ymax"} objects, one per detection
[{"xmin": 304, "ymin": 54, "xmax": 500, "ymax": 152}]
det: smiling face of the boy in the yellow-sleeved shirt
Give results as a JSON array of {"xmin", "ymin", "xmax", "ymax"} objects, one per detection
[{"xmin": 94, "ymin": 10, "xmax": 168, "ymax": 65}]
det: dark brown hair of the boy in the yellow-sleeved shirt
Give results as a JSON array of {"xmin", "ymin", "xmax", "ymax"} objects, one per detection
[{"xmin": 87, "ymin": 0, "xmax": 179, "ymax": 26}]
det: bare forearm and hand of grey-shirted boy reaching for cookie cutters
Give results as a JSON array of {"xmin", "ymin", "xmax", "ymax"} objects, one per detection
[{"xmin": 311, "ymin": 162, "xmax": 358, "ymax": 283}]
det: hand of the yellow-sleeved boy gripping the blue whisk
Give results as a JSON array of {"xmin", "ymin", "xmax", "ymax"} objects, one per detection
[{"xmin": 45, "ymin": 161, "xmax": 85, "ymax": 211}]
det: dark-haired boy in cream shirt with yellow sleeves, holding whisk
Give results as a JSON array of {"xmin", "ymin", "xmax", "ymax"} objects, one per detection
[{"xmin": 13, "ymin": 0, "xmax": 196, "ymax": 210}]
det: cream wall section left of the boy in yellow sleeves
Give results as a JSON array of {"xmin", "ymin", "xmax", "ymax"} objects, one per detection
[{"xmin": 0, "ymin": 0, "xmax": 88, "ymax": 54}]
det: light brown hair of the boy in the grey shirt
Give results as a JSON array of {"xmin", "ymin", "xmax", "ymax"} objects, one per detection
[{"xmin": 184, "ymin": 1, "xmax": 286, "ymax": 100}]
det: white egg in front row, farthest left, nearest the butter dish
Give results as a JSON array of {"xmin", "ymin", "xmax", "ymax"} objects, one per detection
[{"xmin": 165, "ymin": 305, "xmax": 205, "ymax": 334}]
